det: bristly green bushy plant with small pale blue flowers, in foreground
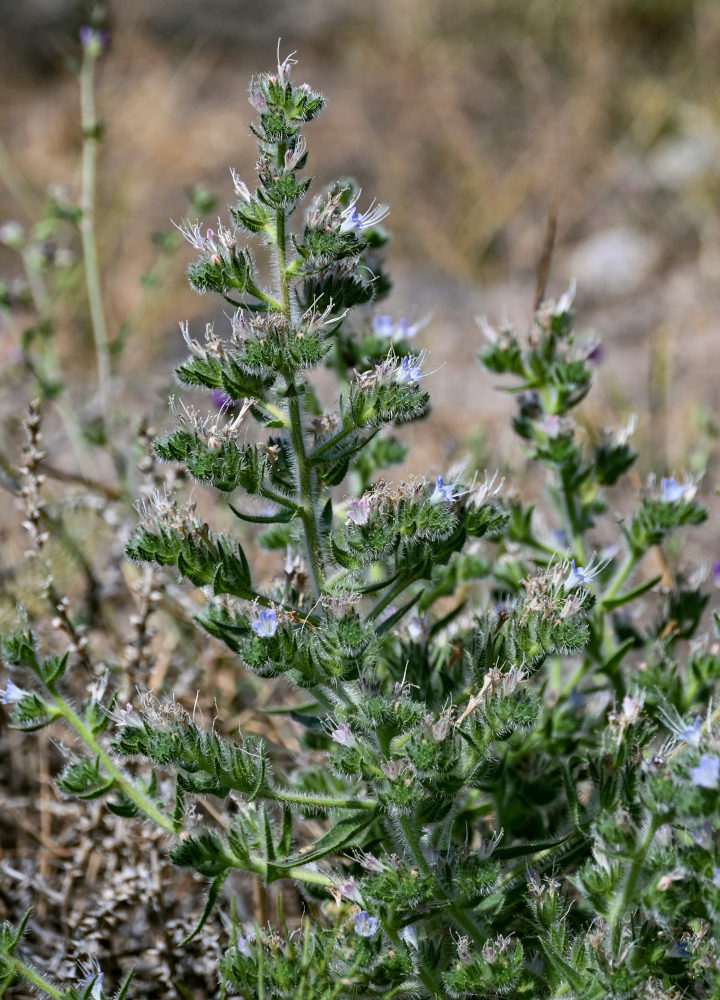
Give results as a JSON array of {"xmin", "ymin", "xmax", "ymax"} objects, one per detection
[{"xmin": 0, "ymin": 47, "xmax": 720, "ymax": 1000}]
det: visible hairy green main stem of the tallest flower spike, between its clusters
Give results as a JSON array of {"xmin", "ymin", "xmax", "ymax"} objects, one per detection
[{"xmin": 276, "ymin": 152, "xmax": 323, "ymax": 599}]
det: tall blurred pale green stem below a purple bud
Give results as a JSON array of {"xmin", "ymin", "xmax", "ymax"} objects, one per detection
[{"xmin": 80, "ymin": 48, "xmax": 112, "ymax": 440}]
